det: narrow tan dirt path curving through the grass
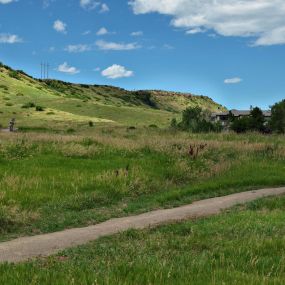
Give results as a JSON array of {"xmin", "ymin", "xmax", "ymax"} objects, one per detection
[{"xmin": 0, "ymin": 187, "xmax": 285, "ymax": 262}]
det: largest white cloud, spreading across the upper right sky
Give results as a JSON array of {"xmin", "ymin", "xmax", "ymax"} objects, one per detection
[{"xmin": 130, "ymin": 0, "xmax": 285, "ymax": 46}]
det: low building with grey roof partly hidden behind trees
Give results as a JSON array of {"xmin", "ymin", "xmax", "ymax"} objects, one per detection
[{"xmin": 211, "ymin": 110, "xmax": 271, "ymax": 126}]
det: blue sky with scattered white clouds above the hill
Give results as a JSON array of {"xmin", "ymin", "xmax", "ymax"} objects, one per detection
[{"xmin": 0, "ymin": 0, "xmax": 285, "ymax": 109}]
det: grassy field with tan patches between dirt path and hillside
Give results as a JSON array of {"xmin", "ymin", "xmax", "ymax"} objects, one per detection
[{"xmin": 0, "ymin": 127, "xmax": 285, "ymax": 240}]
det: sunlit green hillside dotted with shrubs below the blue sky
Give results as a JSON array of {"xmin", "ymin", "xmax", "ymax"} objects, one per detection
[{"xmin": 0, "ymin": 64, "xmax": 224, "ymax": 128}]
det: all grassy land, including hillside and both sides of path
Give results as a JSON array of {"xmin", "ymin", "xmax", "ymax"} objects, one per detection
[{"xmin": 0, "ymin": 66, "xmax": 285, "ymax": 284}]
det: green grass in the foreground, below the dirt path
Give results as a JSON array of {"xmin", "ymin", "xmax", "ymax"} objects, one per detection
[{"xmin": 0, "ymin": 194, "xmax": 285, "ymax": 285}]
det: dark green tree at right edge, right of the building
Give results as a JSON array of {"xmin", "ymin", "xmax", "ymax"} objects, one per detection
[{"xmin": 270, "ymin": 100, "xmax": 285, "ymax": 134}]
